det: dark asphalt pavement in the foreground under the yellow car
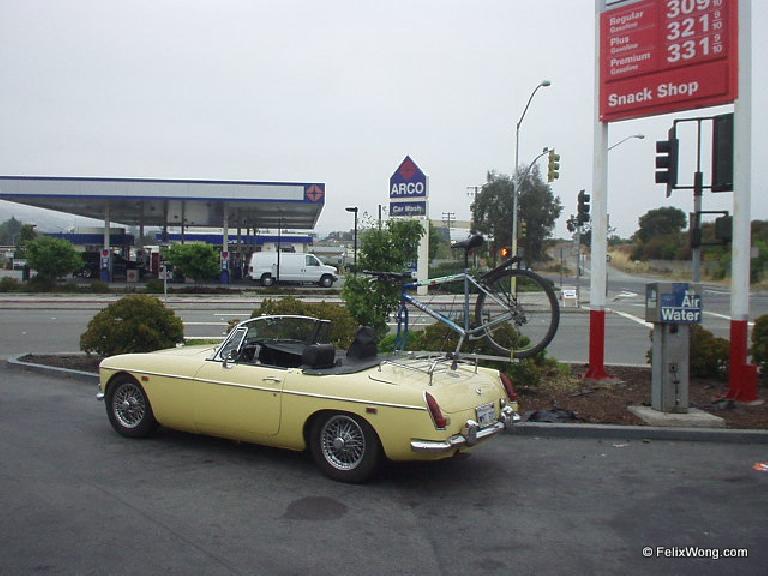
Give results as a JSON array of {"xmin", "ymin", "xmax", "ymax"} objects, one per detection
[{"xmin": 0, "ymin": 368, "xmax": 768, "ymax": 576}]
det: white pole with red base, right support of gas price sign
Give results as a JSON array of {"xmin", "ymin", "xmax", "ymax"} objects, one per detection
[{"xmin": 727, "ymin": 0, "xmax": 758, "ymax": 403}]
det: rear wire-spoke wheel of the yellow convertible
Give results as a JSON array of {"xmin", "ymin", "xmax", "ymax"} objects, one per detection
[{"xmin": 310, "ymin": 413, "xmax": 382, "ymax": 483}]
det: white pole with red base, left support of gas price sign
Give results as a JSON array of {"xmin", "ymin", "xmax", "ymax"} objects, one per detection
[{"xmin": 588, "ymin": 0, "xmax": 611, "ymax": 380}]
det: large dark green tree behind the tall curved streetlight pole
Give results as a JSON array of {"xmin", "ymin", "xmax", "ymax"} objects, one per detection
[{"xmin": 474, "ymin": 167, "xmax": 562, "ymax": 260}]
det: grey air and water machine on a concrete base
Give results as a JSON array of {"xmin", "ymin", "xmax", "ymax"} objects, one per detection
[{"xmin": 645, "ymin": 282, "xmax": 702, "ymax": 414}]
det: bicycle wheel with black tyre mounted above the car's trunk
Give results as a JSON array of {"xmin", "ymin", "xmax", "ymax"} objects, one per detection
[{"xmin": 475, "ymin": 269, "xmax": 560, "ymax": 358}]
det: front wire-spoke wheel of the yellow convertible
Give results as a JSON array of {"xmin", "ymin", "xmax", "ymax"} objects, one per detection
[{"xmin": 105, "ymin": 375, "xmax": 157, "ymax": 438}]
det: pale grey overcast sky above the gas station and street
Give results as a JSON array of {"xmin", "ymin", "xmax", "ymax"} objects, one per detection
[{"xmin": 0, "ymin": 0, "xmax": 768, "ymax": 236}]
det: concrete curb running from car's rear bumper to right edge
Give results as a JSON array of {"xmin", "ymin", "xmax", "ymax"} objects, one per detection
[{"xmin": 509, "ymin": 422, "xmax": 768, "ymax": 444}]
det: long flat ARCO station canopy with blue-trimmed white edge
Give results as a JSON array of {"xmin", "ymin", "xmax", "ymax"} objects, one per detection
[{"xmin": 0, "ymin": 176, "xmax": 325, "ymax": 229}]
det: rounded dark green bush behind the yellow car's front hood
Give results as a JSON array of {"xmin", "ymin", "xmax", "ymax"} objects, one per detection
[{"xmin": 80, "ymin": 295, "xmax": 184, "ymax": 356}]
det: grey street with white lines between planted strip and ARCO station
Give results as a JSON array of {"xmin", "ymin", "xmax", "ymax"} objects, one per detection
[{"xmin": 0, "ymin": 269, "xmax": 768, "ymax": 364}]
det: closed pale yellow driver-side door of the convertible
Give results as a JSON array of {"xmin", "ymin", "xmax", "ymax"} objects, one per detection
[{"xmin": 194, "ymin": 359, "xmax": 288, "ymax": 440}]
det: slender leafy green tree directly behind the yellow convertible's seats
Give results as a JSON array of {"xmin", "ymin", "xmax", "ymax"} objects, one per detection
[{"xmin": 342, "ymin": 218, "xmax": 424, "ymax": 336}]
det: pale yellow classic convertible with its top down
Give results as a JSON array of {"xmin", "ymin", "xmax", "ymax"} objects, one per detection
[{"xmin": 98, "ymin": 316, "xmax": 519, "ymax": 482}]
